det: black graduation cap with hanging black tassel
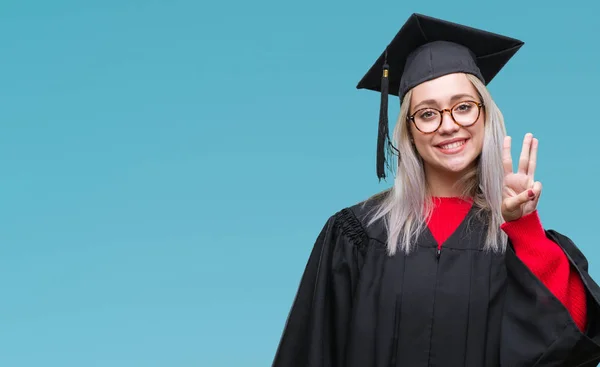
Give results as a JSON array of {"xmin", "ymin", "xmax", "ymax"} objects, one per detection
[{"xmin": 356, "ymin": 14, "xmax": 524, "ymax": 180}]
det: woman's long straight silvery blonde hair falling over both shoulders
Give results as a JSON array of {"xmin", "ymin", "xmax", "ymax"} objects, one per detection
[{"xmin": 367, "ymin": 74, "xmax": 506, "ymax": 255}]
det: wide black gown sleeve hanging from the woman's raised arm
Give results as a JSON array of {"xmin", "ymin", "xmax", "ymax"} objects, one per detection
[{"xmin": 500, "ymin": 214, "xmax": 600, "ymax": 367}]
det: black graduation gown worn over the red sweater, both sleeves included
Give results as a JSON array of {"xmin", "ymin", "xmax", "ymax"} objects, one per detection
[{"xmin": 273, "ymin": 197, "xmax": 600, "ymax": 367}]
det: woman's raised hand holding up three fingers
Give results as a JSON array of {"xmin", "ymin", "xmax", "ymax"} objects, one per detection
[{"xmin": 502, "ymin": 133, "xmax": 542, "ymax": 222}]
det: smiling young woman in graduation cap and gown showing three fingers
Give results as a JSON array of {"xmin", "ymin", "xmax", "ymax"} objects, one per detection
[{"xmin": 273, "ymin": 14, "xmax": 600, "ymax": 367}]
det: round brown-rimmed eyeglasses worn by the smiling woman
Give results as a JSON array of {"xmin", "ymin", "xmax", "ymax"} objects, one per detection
[{"xmin": 407, "ymin": 101, "xmax": 483, "ymax": 134}]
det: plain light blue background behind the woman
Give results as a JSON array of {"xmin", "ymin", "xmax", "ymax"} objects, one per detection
[{"xmin": 0, "ymin": 0, "xmax": 600, "ymax": 367}]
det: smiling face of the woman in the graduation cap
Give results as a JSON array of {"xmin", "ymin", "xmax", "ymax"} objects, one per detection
[{"xmin": 408, "ymin": 74, "xmax": 485, "ymax": 174}]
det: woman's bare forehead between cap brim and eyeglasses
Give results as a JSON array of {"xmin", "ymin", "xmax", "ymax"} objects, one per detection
[{"xmin": 411, "ymin": 73, "xmax": 477, "ymax": 106}]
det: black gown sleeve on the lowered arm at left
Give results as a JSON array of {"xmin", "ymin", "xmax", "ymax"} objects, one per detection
[{"xmin": 272, "ymin": 211, "xmax": 359, "ymax": 367}]
